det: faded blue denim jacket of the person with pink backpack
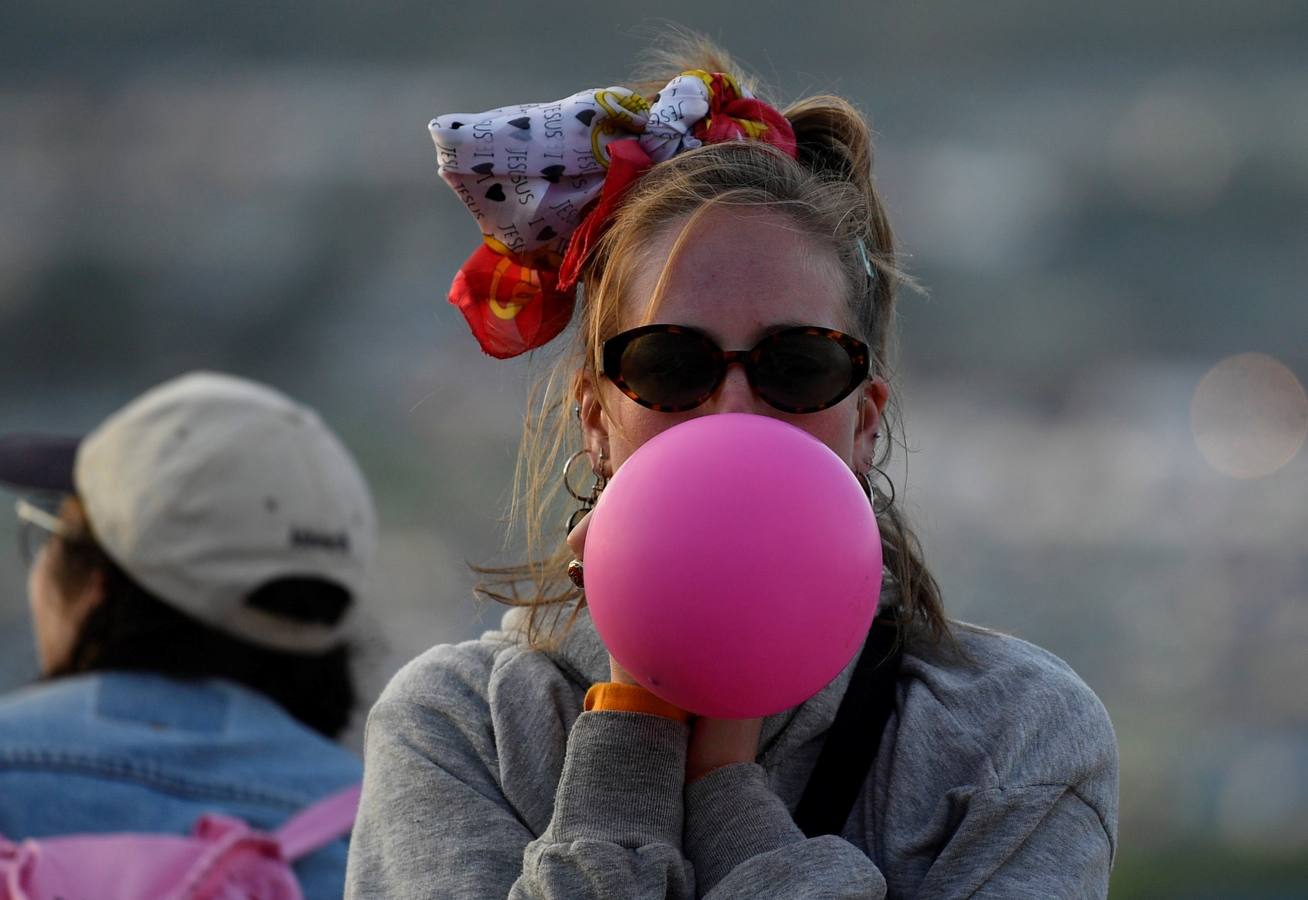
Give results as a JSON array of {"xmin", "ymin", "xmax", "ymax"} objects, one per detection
[{"xmin": 0, "ymin": 672, "xmax": 362, "ymax": 900}]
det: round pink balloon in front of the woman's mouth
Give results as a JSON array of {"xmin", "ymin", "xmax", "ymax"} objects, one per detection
[{"xmin": 586, "ymin": 413, "xmax": 882, "ymax": 718}]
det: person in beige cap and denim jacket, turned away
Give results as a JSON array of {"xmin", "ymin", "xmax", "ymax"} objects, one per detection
[{"xmin": 0, "ymin": 373, "xmax": 377, "ymax": 897}]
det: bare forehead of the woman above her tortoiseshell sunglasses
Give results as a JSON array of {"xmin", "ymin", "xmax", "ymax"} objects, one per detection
[{"xmin": 621, "ymin": 207, "xmax": 849, "ymax": 344}]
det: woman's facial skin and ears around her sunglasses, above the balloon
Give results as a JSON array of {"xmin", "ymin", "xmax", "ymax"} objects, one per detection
[{"xmin": 581, "ymin": 207, "xmax": 887, "ymax": 471}]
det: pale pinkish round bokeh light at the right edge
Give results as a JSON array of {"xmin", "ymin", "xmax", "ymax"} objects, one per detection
[{"xmin": 1190, "ymin": 353, "xmax": 1308, "ymax": 479}]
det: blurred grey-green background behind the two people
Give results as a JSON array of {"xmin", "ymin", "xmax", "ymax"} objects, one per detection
[{"xmin": 0, "ymin": 0, "xmax": 1308, "ymax": 897}]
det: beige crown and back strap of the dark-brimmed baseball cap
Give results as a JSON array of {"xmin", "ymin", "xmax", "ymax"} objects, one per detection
[{"xmin": 8, "ymin": 372, "xmax": 377, "ymax": 653}]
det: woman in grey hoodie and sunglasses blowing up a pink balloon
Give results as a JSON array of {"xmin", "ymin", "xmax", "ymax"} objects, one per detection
[{"xmin": 347, "ymin": 38, "xmax": 1117, "ymax": 897}]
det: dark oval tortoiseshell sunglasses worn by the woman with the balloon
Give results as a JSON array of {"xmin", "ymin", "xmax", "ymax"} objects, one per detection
[{"xmin": 602, "ymin": 324, "xmax": 869, "ymax": 412}]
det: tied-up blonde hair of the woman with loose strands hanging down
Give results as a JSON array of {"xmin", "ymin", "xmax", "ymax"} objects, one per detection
[{"xmin": 475, "ymin": 34, "xmax": 951, "ymax": 645}]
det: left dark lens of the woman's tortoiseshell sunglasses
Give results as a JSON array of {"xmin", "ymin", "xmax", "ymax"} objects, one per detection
[{"xmin": 619, "ymin": 331, "xmax": 721, "ymax": 411}]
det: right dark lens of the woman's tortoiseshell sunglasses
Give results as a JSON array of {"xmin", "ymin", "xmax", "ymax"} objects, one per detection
[{"xmin": 755, "ymin": 331, "xmax": 854, "ymax": 412}]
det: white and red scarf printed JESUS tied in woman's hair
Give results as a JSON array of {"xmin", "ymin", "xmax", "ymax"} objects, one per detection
[{"xmin": 429, "ymin": 69, "xmax": 795, "ymax": 358}]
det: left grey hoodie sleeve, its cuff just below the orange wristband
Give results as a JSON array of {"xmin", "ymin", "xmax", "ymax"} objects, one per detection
[{"xmin": 345, "ymin": 648, "xmax": 695, "ymax": 900}]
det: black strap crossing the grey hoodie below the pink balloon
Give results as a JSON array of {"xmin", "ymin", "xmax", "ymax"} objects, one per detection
[{"xmin": 795, "ymin": 611, "xmax": 903, "ymax": 837}]
